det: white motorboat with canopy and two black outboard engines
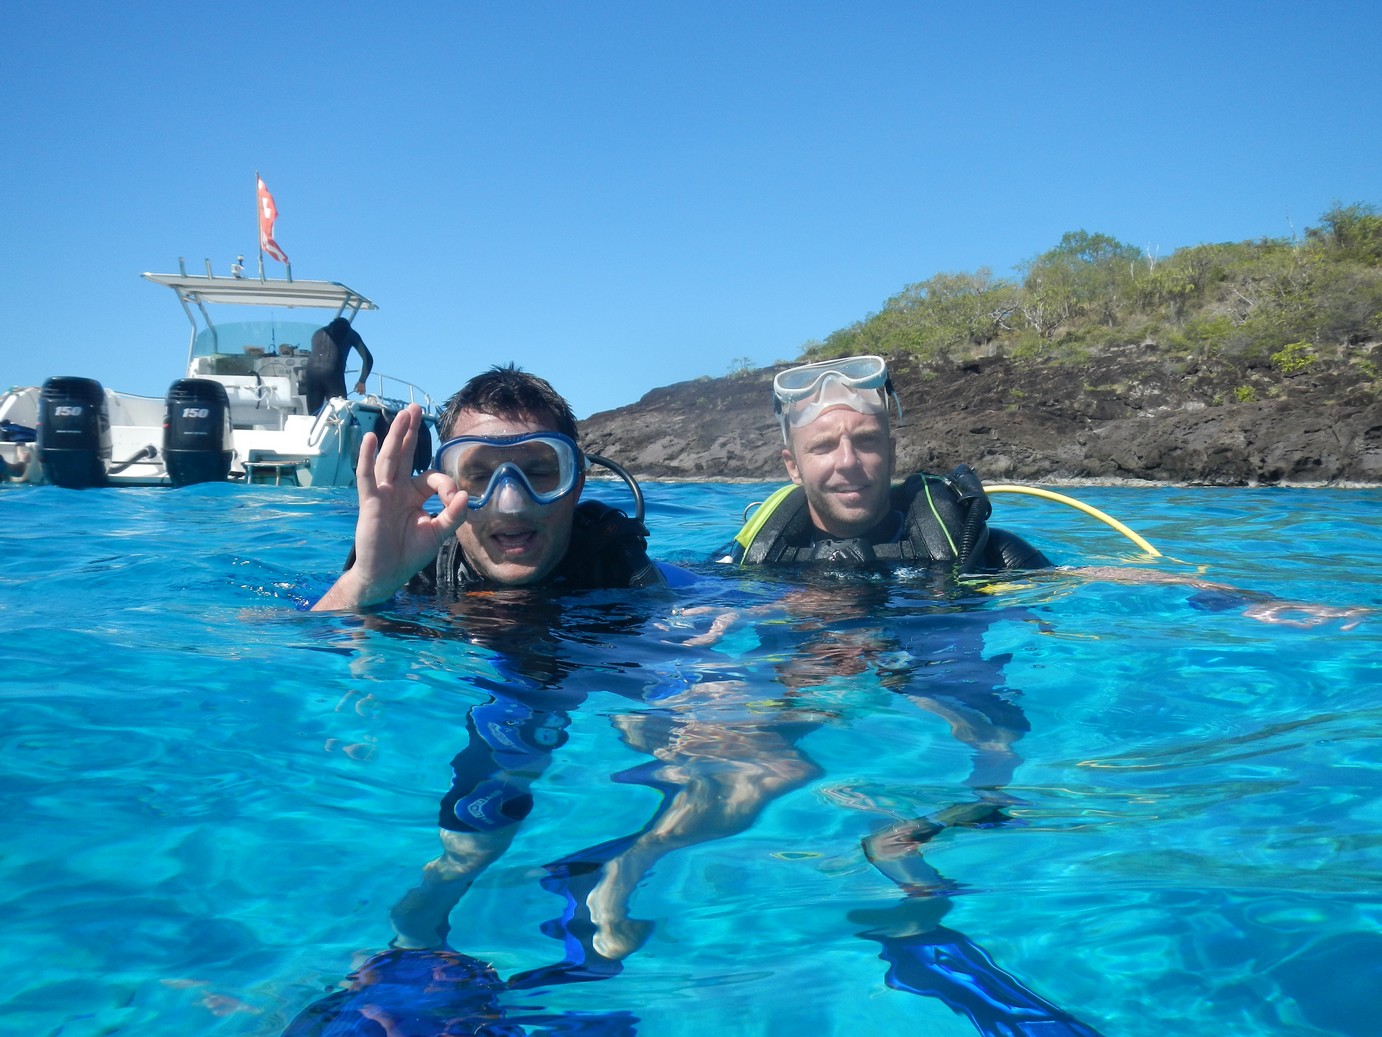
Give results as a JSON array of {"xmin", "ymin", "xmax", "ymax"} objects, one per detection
[{"xmin": 0, "ymin": 261, "xmax": 437, "ymax": 488}]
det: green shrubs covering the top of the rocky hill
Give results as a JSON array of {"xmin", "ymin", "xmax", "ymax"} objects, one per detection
[{"xmin": 804, "ymin": 205, "xmax": 1382, "ymax": 373}]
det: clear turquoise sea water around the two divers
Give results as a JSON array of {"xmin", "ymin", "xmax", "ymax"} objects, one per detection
[{"xmin": 0, "ymin": 484, "xmax": 1382, "ymax": 1037}]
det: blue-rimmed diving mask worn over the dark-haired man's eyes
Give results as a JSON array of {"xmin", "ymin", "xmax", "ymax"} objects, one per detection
[{"xmin": 434, "ymin": 433, "xmax": 586, "ymax": 510}]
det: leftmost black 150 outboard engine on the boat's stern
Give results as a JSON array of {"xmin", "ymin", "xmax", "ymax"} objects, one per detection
[{"xmin": 37, "ymin": 375, "xmax": 111, "ymax": 489}]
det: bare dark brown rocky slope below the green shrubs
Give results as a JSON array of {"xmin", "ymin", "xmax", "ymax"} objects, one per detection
[{"xmin": 582, "ymin": 344, "xmax": 1382, "ymax": 485}]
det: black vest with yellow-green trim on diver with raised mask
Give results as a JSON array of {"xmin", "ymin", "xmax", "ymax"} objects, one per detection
[{"xmin": 734, "ymin": 465, "xmax": 1050, "ymax": 571}]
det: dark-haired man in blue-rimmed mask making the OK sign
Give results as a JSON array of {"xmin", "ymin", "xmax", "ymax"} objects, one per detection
[{"xmin": 314, "ymin": 366, "xmax": 674, "ymax": 973}]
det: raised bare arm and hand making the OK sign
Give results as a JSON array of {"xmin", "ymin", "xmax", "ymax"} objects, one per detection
[{"xmin": 312, "ymin": 404, "xmax": 466, "ymax": 611}]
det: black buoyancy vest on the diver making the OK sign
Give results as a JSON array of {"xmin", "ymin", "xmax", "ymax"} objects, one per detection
[{"xmin": 406, "ymin": 501, "xmax": 666, "ymax": 595}]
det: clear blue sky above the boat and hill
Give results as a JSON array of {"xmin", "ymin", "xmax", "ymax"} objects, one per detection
[{"xmin": 0, "ymin": 0, "xmax": 1382, "ymax": 416}]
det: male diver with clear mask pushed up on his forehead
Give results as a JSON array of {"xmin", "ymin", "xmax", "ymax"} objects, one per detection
[{"xmin": 746, "ymin": 357, "xmax": 1097, "ymax": 1037}]
